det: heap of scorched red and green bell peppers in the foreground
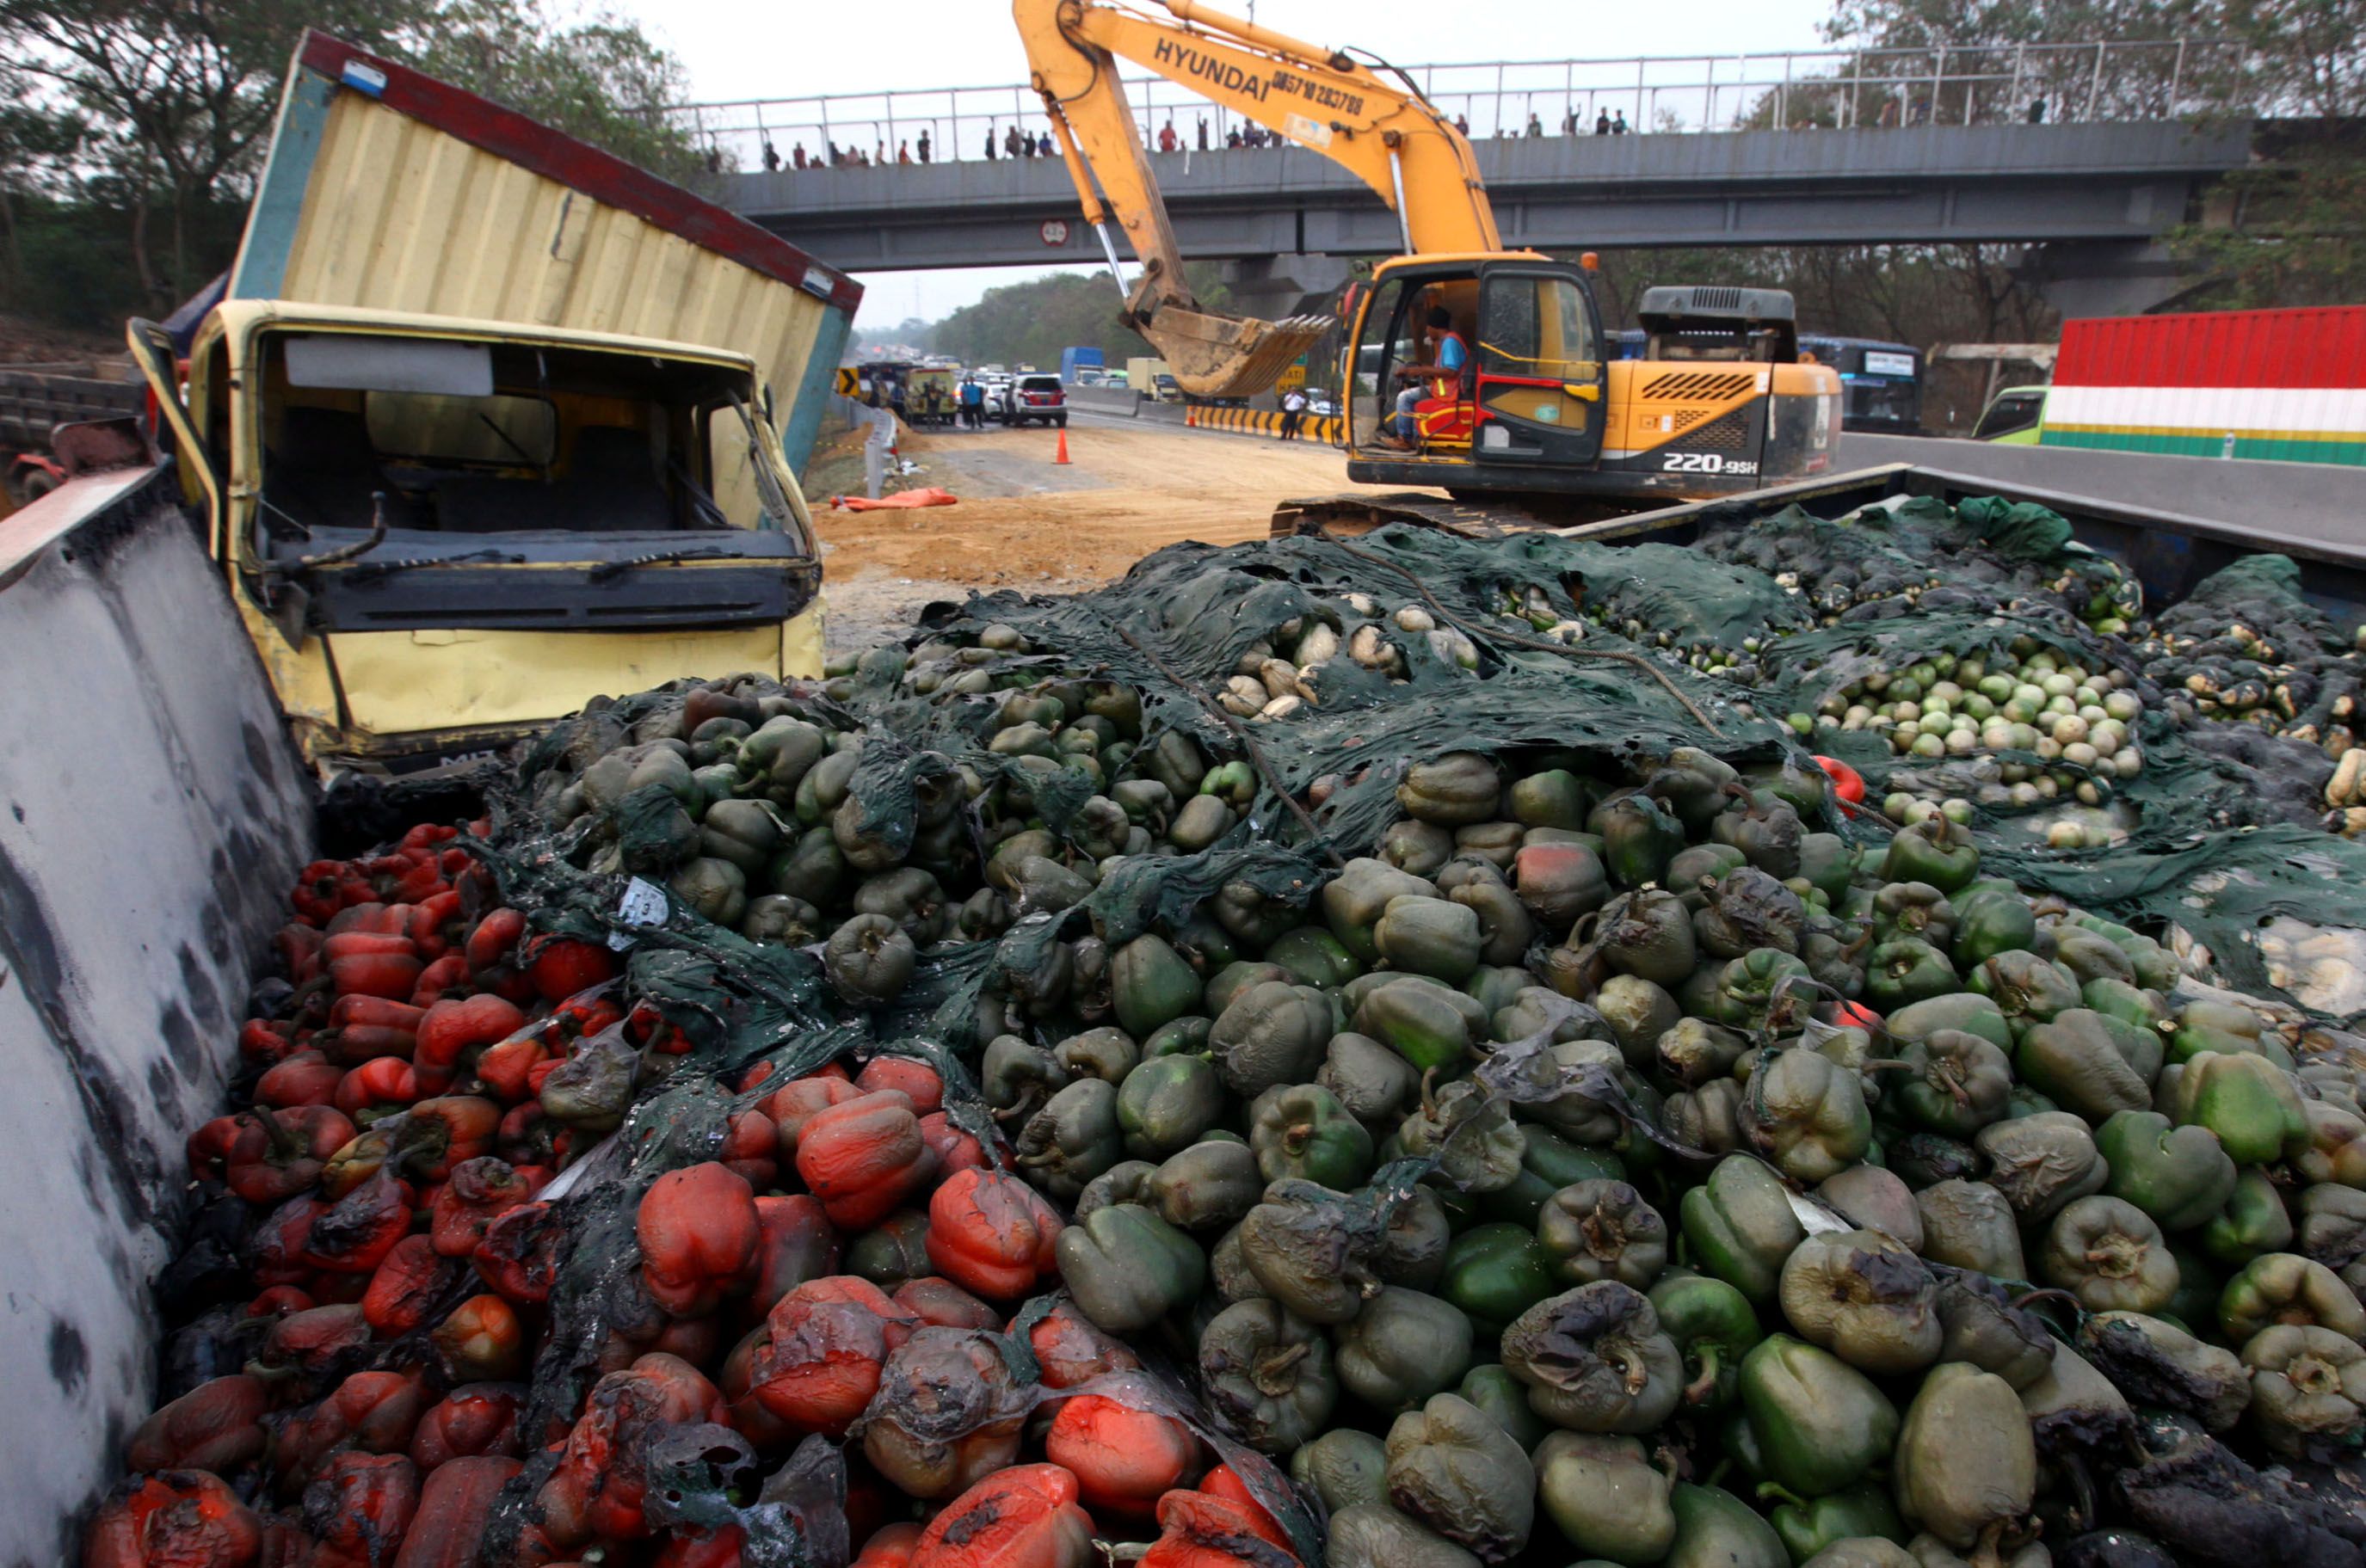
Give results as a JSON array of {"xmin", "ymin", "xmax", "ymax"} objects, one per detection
[{"xmin": 85, "ymin": 588, "xmax": 2366, "ymax": 1568}]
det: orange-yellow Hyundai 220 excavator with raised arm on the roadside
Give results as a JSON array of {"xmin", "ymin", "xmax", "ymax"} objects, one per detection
[{"xmin": 1010, "ymin": 0, "xmax": 1841, "ymax": 530}]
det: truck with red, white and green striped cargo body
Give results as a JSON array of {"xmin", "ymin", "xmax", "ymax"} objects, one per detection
[{"xmin": 1974, "ymin": 305, "xmax": 2366, "ymax": 468}]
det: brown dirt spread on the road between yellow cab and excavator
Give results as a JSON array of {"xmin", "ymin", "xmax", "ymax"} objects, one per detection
[{"xmin": 814, "ymin": 419, "xmax": 1410, "ymax": 648}]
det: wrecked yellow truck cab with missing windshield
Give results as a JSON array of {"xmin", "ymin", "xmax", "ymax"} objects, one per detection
[{"xmin": 128, "ymin": 298, "xmax": 821, "ymax": 766}]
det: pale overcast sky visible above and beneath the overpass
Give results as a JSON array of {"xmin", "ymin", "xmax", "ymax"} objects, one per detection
[{"xmin": 615, "ymin": 0, "xmax": 1832, "ymax": 331}]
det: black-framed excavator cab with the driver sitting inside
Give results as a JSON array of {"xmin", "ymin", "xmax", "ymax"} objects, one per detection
[{"xmin": 1346, "ymin": 253, "xmax": 1609, "ymax": 492}]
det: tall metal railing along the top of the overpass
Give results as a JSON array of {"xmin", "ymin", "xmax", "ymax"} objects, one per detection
[{"xmin": 675, "ymin": 38, "xmax": 2264, "ymax": 170}]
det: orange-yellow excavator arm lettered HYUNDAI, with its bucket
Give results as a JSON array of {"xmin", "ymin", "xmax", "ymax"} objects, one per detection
[{"xmin": 1010, "ymin": 0, "xmax": 1502, "ymax": 397}]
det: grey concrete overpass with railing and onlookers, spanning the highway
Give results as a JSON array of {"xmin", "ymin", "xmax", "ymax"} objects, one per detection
[{"xmin": 687, "ymin": 42, "xmax": 2252, "ymax": 315}]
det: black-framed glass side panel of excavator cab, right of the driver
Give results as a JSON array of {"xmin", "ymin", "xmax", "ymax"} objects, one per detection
[{"xmin": 1472, "ymin": 262, "xmax": 1606, "ymax": 468}]
